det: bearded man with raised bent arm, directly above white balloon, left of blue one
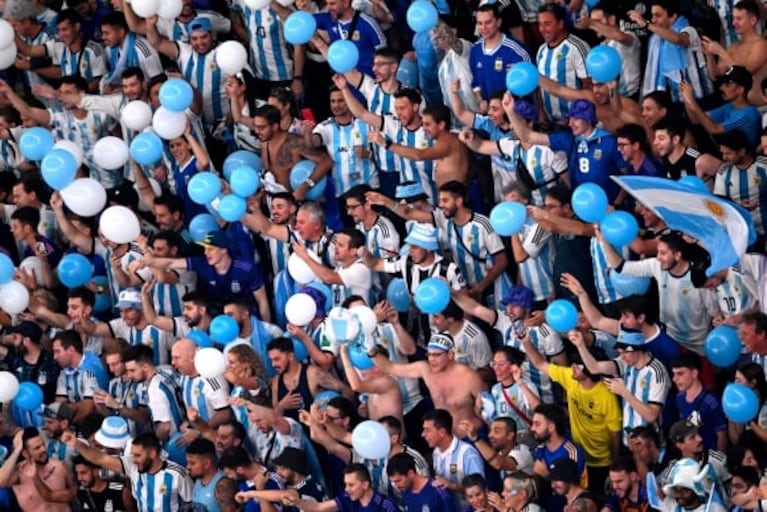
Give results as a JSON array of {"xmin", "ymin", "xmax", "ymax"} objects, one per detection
[{"xmin": 141, "ymin": 290, "xmax": 213, "ymax": 338}]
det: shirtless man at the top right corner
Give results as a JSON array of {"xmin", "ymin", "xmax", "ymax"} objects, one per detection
[{"xmin": 701, "ymin": 0, "xmax": 767, "ymax": 105}]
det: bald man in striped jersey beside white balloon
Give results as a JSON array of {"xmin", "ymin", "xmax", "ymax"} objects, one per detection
[{"xmin": 171, "ymin": 338, "xmax": 232, "ymax": 443}]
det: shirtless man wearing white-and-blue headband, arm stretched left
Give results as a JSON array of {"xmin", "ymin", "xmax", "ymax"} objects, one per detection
[{"xmin": 368, "ymin": 333, "xmax": 485, "ymax": 435}]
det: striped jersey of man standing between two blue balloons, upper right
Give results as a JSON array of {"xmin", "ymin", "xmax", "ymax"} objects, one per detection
[{"xmin": 536, "ymin": 34, "xmax": 590, "ymax": 122}]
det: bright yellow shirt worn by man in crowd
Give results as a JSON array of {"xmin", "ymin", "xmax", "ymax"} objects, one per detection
[{"xmin": 549, "ymin": 364, "xmax": 622, "ymax": 467}]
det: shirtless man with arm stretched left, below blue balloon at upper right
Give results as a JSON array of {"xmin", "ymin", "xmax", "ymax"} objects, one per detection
[{"xmin": 539, "ymin": 75, "xmax": 652, "ymax": 137}]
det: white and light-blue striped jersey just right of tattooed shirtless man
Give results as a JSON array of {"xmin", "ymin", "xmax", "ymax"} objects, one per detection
[{"xmin": 312, "ymin": 117, "xmax": 378, "ymax": 197}]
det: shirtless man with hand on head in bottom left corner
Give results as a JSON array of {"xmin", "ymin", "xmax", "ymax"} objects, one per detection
[{"xmin": 0, "ymin": 427, "xmax": 77, "ymax": 512}]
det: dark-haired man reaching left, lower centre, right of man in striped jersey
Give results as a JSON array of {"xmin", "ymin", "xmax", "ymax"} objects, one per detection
[{"xmin": 458, "ymin": 416, "xmax": 533, "ymax": 479}]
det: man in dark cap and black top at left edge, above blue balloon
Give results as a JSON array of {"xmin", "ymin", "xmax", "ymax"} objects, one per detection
[{"xmin": 0, "ymin": 320, "xmax": 61, "ymax": 403}]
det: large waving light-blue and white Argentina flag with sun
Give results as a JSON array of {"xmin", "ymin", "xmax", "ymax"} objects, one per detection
[{"xmin": 611, "ymin": 176, "xmax": 756, "ymax": 277}]
